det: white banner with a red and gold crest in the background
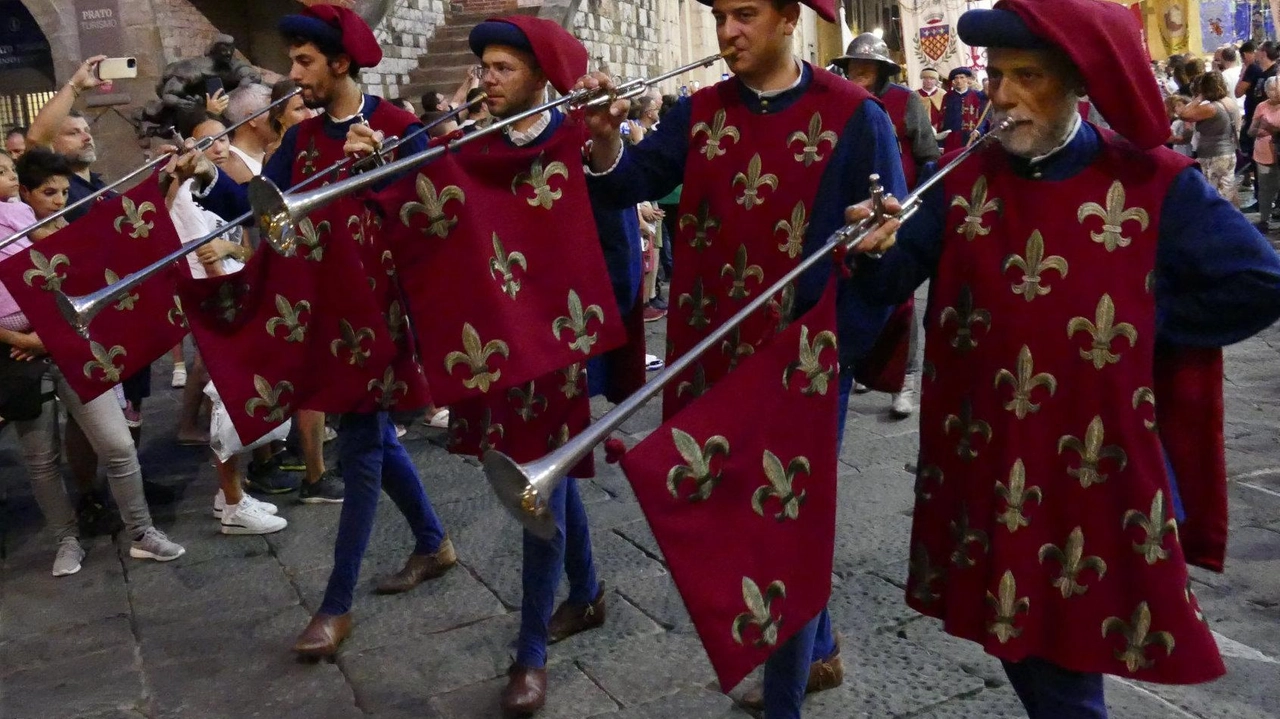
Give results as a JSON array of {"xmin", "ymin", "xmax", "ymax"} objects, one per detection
[{"xmin": 901, "ymin": 0, "xmax": 992, "ymax": 87}]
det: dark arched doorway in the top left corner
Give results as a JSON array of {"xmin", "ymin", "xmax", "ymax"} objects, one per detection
[{"xmin": 0, "ymin": 0, "xmax": 58, "ymax": 129}]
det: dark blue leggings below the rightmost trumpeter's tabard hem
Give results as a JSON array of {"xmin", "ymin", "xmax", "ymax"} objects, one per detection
[{"xmin": 1001, "ymin": 656, "xmax": 1107, "ymax": 719}]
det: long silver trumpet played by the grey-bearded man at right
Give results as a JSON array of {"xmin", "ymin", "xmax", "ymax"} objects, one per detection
[{"xmin": 483, "ymin": 120, "xmax": 1015, "ymax": 540}]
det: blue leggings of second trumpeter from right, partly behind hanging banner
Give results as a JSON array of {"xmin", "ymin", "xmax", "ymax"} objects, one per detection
[{"xmin": 764, "ymin": 370, "xmax": 854, "ymax": 719}]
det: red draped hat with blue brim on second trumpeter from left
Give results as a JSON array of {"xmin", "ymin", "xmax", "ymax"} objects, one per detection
[{"xmin": 468, "ymin": 15, "xmax": 588, "ymax": 95}]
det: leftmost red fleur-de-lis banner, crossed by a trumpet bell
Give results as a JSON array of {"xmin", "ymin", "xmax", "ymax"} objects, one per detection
[{"xmin": 0, "ymin": 175, "xmax": 187, "ymax": 402}]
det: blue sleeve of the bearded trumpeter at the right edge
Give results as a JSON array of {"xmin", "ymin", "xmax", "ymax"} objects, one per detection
[{"xmin": 1156, "ymin": 168, "xmax": 1280, "ymax": 347}]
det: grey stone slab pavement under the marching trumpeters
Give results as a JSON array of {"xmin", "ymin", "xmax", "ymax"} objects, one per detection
[{"xmin": 0, "ymin": 314, "xmax": 1280, "ymax": 719}]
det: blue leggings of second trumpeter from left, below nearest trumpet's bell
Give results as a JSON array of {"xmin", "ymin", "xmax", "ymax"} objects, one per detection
[{"xmin": 516, "ymin": 477, "xmax": 600, "ymax": 668}]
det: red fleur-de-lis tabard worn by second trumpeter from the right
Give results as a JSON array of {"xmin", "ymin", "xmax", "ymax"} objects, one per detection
[{"xmin": 663, "ymin": 68, "xmax": 870, "ymax": 418}]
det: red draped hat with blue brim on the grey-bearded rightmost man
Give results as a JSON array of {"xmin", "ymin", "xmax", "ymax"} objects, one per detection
[{"xmin": 957, "ymin": 0, "xmax": 1169, "ymax": 150}]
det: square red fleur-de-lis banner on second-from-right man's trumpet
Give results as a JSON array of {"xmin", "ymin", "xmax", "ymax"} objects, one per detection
[{"xmin": 374, "ymin": 119, "xmax": 626, "ymax": 406}]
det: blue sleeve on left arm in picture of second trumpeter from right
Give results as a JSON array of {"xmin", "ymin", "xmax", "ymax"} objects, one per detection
[{"xmin": 586, "ymin": 99, "xmax": 692, "ymax": 210}]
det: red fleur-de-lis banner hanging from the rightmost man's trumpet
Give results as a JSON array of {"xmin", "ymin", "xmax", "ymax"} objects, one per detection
[{"xmin": 622, "ymin": 277, "xmax": 840, "ymax": 692}]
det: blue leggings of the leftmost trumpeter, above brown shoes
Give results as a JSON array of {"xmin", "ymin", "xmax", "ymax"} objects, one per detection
[{"xmin": 320, "ymin": 412, "xmax": 444, "ymax": 614}]
